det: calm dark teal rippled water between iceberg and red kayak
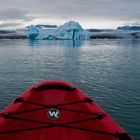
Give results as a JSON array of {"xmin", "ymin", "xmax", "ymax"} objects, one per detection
[{"xmin": 0, "ymin": 40, "xmax": 140, "ymax": 140}]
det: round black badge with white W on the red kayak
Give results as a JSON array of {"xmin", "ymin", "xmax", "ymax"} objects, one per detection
[{"xmin": 48, "ymin": 108, "xmax": 60, "ymax": 119}]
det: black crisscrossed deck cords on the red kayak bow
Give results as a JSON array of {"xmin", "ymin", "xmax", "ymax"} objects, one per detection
[{"xmin": 0, "ymin": 95, "xmax": 131, "ymax": 140}]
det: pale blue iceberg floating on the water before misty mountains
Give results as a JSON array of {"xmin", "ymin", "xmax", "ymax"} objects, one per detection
[{"xmin": 28, "ymin": 21, "xmax": 91, "ymax": 40}]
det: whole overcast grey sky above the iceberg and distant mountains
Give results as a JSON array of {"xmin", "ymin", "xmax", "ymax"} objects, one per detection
[{"xmin": 0, "ymin": 0, "xmax": 140, "ymax": 29}]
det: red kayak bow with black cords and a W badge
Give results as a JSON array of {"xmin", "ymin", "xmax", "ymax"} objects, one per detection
[{"xmin": 0, "ymin": 80, "xmax": 133, "ymax": 140}]
